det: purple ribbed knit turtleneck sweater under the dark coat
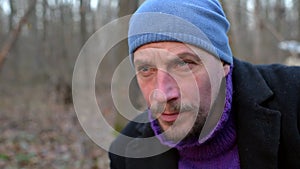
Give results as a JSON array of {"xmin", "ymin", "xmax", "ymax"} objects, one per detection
[{"xmin": 149, "ymin": 68, "xmax": 240, "ymax": 169}]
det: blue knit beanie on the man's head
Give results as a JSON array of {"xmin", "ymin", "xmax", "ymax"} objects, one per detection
[{"xmin": 128, "ymin": 0, "xmax": 233, "ymax": 64}]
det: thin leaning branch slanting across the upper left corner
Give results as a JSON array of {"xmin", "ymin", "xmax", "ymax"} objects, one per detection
[{"xmin": 0, "ymin": 0, "xmax": 37, "ymax": 69}]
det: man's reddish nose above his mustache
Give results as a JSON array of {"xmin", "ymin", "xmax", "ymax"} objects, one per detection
[{"xmin": 153, "ymin": 70, "xmax": 180, "ymax": 102}]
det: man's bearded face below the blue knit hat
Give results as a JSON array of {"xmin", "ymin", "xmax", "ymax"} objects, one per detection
[{"xmin": 134, "ymin": 42, "xmax": 228, "ymax": 141}]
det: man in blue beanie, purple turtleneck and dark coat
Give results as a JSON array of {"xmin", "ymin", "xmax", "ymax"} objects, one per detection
[{"xmin": 109, "ymin": 0, "xmax": 300, "ymax": 169}]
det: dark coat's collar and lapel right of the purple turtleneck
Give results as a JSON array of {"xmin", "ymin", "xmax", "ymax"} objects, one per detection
[{"xmin": 233, "ymin": 59, "xmax": 281, "ymax": 169}]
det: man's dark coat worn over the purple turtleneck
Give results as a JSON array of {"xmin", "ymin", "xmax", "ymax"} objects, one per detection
[{"xmin": 109, "ymin": 59, "xmax": 300, "ymax": 169}]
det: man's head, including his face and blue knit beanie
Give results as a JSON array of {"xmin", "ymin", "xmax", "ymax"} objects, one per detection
[{"xmin": 128, "ymin": 0, "xmax": 232, "ymax": 141}]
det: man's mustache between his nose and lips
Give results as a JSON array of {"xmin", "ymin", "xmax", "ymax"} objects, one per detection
[{"xmin": 150, "ymin": 102, "xmax": 199, "ymax": 114}]
